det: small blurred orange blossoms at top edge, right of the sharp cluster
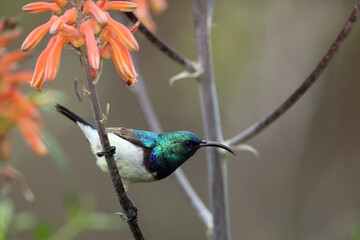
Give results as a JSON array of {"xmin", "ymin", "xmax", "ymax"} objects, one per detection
[{"xmin": 131, "ymin": 0, "xmax": 167, "ymax": 31}]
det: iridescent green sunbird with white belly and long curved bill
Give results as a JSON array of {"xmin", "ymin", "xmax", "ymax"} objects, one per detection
[{"xmin": 55, "ymin": 104, "xmax": 235, "ymax": 190}]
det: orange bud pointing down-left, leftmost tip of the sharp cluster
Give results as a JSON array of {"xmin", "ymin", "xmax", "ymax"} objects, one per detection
[{"xmin": 21, "ymin": 16, "xmax": 58, "ymax": 51}]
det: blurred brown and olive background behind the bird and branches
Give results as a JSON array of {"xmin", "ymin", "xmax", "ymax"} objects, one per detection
[{"xmin": 0, "ymin": 0, "xmax": 360, "ymax": 240}]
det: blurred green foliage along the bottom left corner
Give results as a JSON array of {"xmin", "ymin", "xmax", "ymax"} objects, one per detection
[{"xmin": 0, "ymin": 190, "xmax": 124, "ymax": 240}]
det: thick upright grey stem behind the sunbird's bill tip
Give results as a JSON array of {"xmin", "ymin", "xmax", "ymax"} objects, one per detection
[{"xmin": 194, "ymin": 0, "xmax": 230, "ymax": 240}]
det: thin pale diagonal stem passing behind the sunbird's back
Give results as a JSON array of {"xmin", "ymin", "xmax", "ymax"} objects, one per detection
[{"xmin": 132, "ymin": 66, "xmax": 213, "ymax": 229}]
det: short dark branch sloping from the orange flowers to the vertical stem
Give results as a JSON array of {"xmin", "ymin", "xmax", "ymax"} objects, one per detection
[{"xmin": 125, "ymin": 12, "xmax": 197, "ymax": 72}]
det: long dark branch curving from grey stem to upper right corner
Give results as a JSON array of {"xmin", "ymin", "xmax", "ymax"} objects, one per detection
[{"xmin": 226, "ymin": 0, "xmax": 360, "ymax": 145}]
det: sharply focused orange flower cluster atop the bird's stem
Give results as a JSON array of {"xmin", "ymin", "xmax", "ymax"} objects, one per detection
[{"xmin": 21, "ymin": 0, "xmax": 139, "ymax": 89}]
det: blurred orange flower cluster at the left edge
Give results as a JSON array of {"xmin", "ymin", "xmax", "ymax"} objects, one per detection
[{"xmin": 0, "ymin": 19, "xmax": 47, "ymax": 159}]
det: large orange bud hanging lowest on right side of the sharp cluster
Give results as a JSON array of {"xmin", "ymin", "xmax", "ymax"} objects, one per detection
[{"xmin": 100, "ymin": 27, "xmax": 137, "ymax": 86}]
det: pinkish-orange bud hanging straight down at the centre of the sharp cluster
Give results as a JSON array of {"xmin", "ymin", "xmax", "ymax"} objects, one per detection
[{"xmin": 80, "ymin": 21, "xmax": 100, "ymax": 69}]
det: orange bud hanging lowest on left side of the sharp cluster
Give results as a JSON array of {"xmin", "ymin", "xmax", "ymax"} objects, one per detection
[{"xmin": 45, "ymin": 32, "xmax": 70, "ymax": 82}]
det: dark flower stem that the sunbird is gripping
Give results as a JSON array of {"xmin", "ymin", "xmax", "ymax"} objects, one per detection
[{"xmin": 80, "ymin": 51, "xmax": 144, "ymax": 240}]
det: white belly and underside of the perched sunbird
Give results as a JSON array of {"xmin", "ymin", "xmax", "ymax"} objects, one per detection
[{"xmin": 78, "ymin": 124, "xmax": 154, "ymax": 188}]
